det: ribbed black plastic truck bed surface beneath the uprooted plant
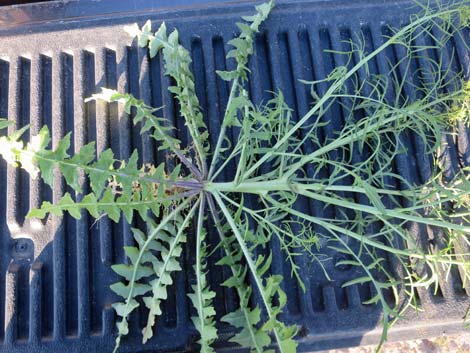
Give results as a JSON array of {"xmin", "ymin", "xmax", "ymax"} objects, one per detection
[{"xmin": 0, "ymin": 0, "xmax": 470, "ymax": 353}]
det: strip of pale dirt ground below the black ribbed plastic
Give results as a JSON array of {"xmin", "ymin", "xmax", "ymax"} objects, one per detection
[{"xmin": 325, "ymin": 333, "xmax": 470, "ymax": 353}]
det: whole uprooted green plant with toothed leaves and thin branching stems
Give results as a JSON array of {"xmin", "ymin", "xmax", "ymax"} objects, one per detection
[{"xmin": 0, "ymin": 1, "xmax": 470, "ymax": 353}]
